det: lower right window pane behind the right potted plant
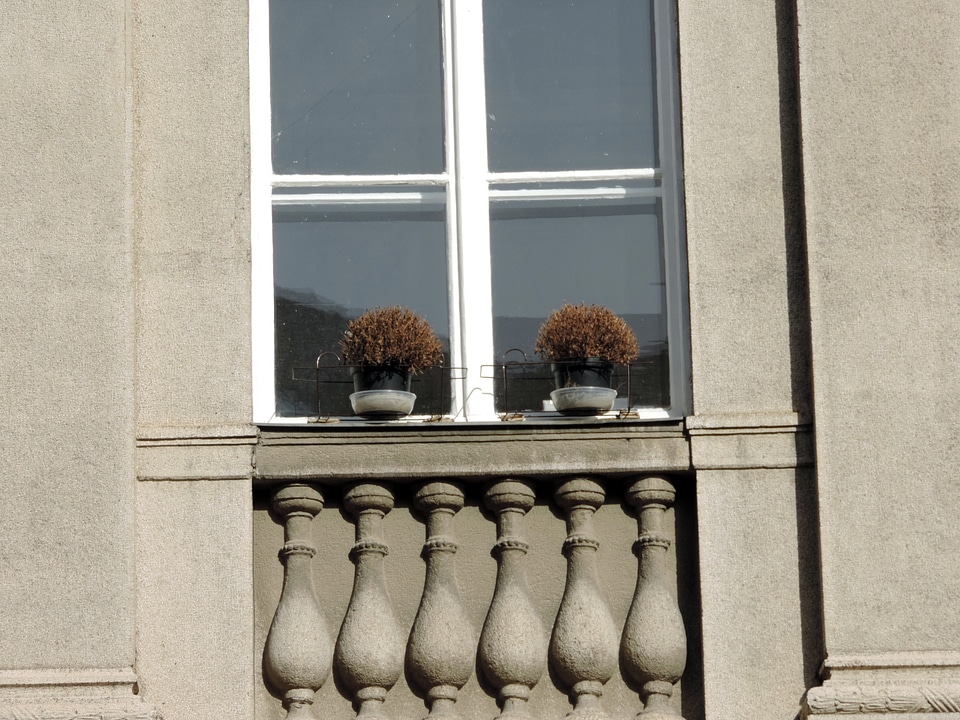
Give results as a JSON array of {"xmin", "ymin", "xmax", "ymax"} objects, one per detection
[{"xmin": 490, "ymin": 198, "xmax": 670, "ymax": 411}]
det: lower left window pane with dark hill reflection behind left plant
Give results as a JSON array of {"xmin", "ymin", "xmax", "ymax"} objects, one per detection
[{"xmin": 273, "ymin": 200, "xmax": 449, "ymax": 417}]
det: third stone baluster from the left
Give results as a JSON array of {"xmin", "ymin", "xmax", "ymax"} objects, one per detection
[{"xmin": 407, "ymin": 482, "xmax": 475, "ymax": 718}]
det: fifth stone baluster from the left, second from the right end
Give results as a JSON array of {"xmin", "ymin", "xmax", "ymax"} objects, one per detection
[{"xmin": 550, "ymin": 477, "xmax": 617, "ymax": 720}]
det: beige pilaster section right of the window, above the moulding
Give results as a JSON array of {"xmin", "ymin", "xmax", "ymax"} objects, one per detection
[{"xmin": 679, "ymin": 0, "xmax": 808, "ymax": 414}]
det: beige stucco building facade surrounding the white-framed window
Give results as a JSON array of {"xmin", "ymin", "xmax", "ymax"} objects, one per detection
[{"xmin": 0, "ymin": 0, "xmax": 960, "ymax": 720}]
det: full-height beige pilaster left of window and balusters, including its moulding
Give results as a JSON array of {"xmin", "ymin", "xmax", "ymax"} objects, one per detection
[{"xmin": 130, "ymin": 0, "xmax": 255, "ymax": 720}]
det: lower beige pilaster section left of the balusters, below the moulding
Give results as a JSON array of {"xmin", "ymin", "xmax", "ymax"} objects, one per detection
[{"xmin": 137, "ymin": 480, "xmax": 255, "ymax": 720}]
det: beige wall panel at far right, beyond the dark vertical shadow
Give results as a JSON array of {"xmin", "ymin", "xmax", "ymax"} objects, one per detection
[{"xmin": 798, "ymin": 0, "xmax": 960, "ymax": 660}]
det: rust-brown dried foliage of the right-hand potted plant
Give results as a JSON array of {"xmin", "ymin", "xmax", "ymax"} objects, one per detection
[{"xmin": 534, "ymin": 303, "xmax": 639, "ymax": 363}]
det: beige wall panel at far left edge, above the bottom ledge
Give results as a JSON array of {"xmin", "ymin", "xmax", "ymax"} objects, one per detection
[{"xmin": 0, "ymin": 0, "xmax": 134, "ymax": 668}]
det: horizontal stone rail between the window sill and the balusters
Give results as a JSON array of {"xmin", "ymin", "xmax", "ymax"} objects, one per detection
[{"xmin": 254, "ymin": 422, "xmax": 691, "ymax": 485}]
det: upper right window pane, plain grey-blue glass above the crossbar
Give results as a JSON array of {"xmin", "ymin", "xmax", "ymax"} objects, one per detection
[{"xmin": 483, "ymin": 0, "xmax": 658, "ymax": 171}]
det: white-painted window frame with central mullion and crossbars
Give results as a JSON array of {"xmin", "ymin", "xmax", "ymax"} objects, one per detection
[{"xmin": 250, "ymin": 0, "xmax": 691, "ymax": 425}]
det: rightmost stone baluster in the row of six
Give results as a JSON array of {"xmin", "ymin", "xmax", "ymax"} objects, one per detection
[{"xmin": 620, "ymin": 477, "xmax": 687, "ymax": 720}]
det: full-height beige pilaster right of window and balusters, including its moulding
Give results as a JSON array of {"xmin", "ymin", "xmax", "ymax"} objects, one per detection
[{"xmin": 679, "ymin": 0, "xmax": 820, "ymax": 718}]
